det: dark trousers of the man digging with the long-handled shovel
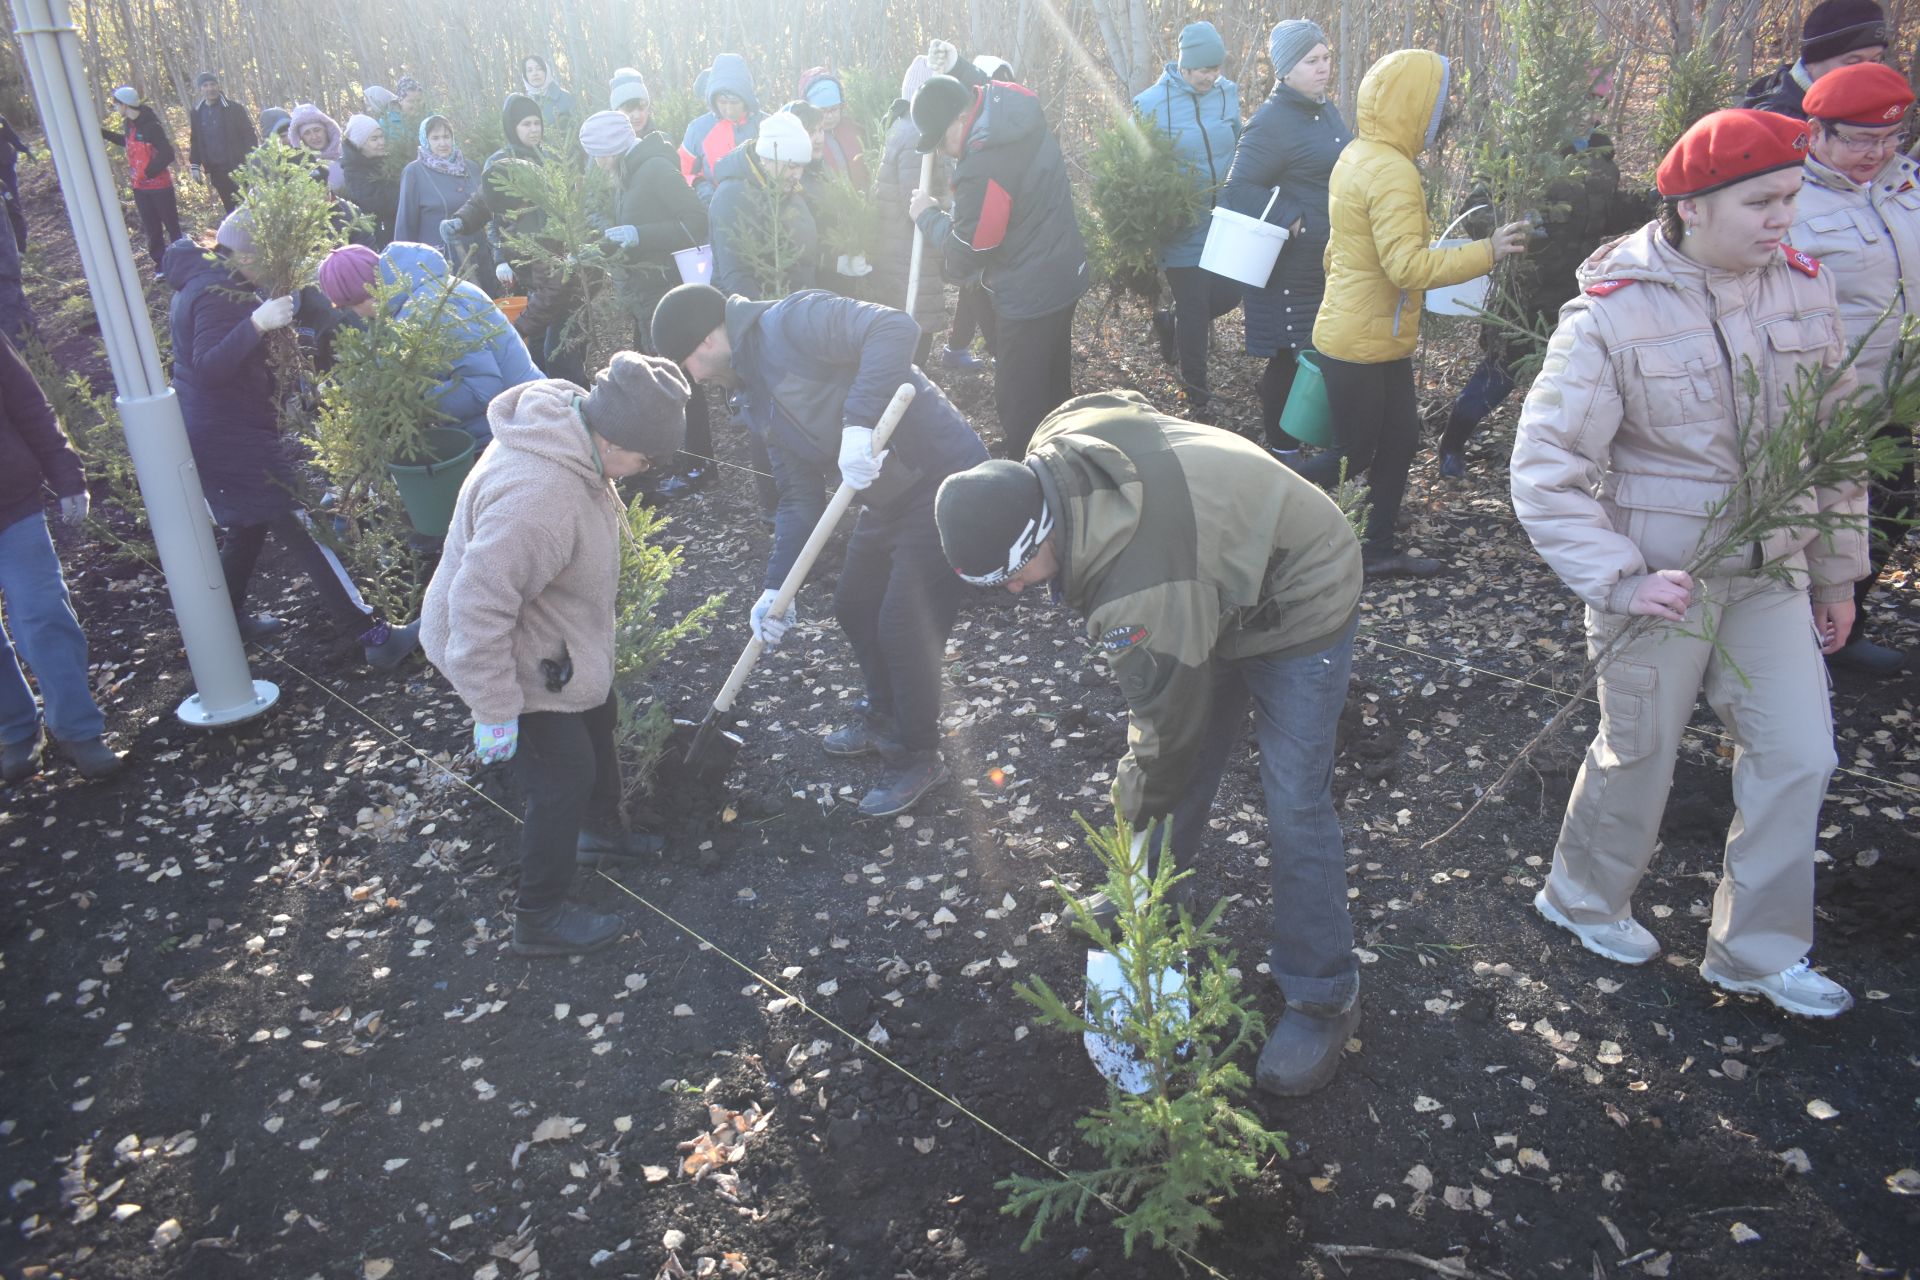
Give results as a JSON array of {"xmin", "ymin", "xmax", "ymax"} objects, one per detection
[{"xmin": 833, "ymin": 486, "xmax": 966, "ymax": 752}]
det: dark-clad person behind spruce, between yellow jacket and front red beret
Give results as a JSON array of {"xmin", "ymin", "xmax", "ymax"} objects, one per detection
[{"xmin": 1440, "ymin": 69, "xmax": 1651, "ymax": 480}]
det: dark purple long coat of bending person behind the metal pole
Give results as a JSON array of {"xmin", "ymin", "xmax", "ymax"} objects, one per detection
[{"xmin": 161, "ymin": 240, "xmax": 296, "ymax": 526}]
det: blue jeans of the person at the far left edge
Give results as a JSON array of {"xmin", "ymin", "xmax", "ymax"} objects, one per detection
[{"xmin": 0, "ymin": 514, "xmax": 108, "ymax": 747}]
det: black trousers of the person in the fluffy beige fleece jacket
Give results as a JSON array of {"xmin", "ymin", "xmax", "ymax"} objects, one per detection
[{"xmin": 513, "ymin": 691, "xmax": 620, "ymax": 912}]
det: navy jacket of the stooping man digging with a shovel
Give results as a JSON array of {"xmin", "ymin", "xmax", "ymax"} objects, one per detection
[{"xmin": 726, "ymin": 290, "xmax": 987, "ymax": 589}]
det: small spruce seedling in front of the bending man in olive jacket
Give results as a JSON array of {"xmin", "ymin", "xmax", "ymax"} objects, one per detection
[{"xmin": 996, "ymin": 814, "xmax": 1286, "ymax": 1257}]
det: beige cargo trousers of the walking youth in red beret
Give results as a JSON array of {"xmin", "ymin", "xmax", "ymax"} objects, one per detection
[{"xmin": 1546, "ymin": 578, "xmax": 1837, "ymax": 979}]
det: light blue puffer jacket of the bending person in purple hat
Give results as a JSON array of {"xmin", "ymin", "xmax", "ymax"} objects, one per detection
[{"xmin": 380, "ymin": 240, "xmax": 545, "ymax": 443}]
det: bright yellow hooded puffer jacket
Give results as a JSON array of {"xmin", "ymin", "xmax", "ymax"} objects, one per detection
[{"xmin": 1313, "ymin": 48, "xmax": 1494, "ymax": 365}]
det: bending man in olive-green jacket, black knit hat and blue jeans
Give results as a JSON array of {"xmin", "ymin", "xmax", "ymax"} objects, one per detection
[{"xmin": 935, "ymin": 391, "xmax": 1363, "ymax": 1098}]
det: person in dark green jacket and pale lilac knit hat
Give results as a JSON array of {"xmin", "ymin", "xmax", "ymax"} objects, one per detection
[{"xmin": 580, "ymin": 107, "xmax": 714, "ymax": 501}]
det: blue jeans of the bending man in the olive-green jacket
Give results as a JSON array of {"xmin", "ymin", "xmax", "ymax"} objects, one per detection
[{"xmin": 1173, "ymin": 620, "xmax": 1359, "ymax": 1015}]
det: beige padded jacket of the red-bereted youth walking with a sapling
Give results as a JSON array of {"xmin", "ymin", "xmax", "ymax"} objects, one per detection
[{"xmin": 1513, "ymin": 223, "xmax": 1866, "ymax": 614}]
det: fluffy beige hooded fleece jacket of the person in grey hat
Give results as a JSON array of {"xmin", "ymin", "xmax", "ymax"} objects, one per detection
[{"xmin": 420, "ymin": 380, "xmax": 622, "ymax": 723}]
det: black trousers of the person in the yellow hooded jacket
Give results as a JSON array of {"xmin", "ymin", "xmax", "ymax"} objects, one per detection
[{"xmin": 1298, "ymin": 353, "xmax": 1421, "ymax": 555}]
